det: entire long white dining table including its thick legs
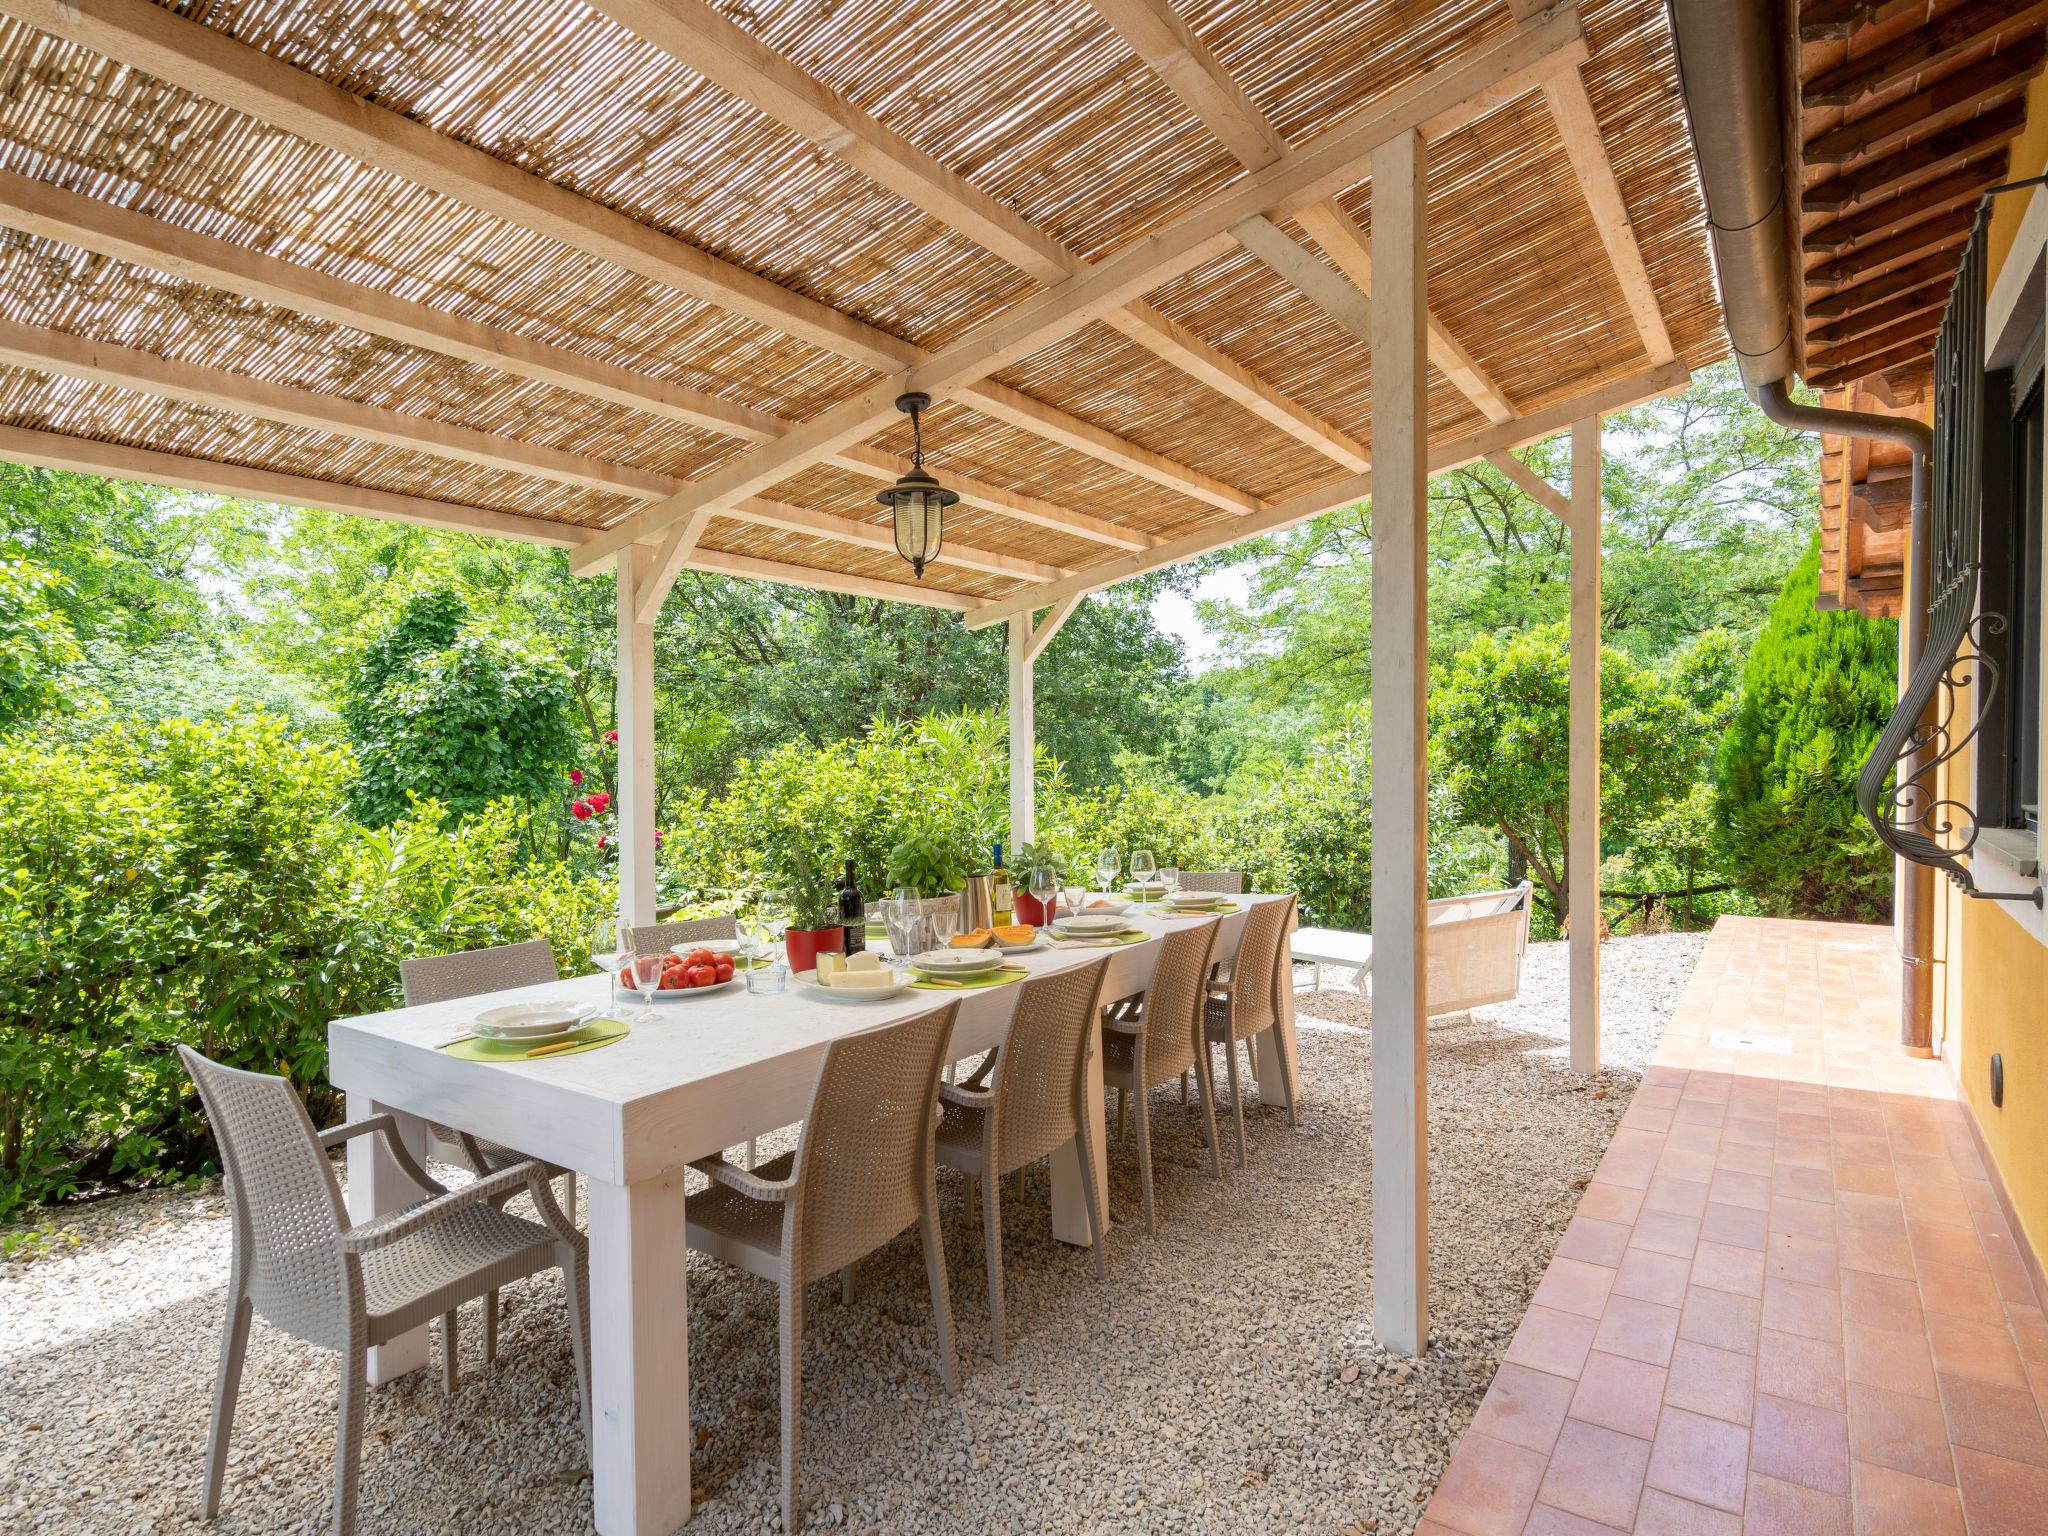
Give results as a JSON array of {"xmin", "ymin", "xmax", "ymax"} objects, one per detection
[{"xmin": 328, "ymin": 895, "xmax": 1296, "ymax": 1536}]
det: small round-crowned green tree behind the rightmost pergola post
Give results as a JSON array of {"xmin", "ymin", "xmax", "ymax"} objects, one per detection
[{"xmin": 1430, "ymin": 625, "xmax": 1706, "ymax": 915}]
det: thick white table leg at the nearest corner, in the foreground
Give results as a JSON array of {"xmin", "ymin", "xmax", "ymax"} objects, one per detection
[{"xmin": 584, "ymin": 1169, "xmax": 690, "ymax": 1536}]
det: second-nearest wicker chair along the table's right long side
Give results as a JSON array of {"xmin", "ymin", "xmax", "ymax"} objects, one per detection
[{"xmin": 938, "ymin": 956, "xmax": 1110, "ymax": 1362}]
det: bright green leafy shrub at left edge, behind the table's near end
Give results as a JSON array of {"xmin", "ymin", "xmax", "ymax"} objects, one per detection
[{"xmin": 0, "ymin": 715, "xmax": 614, "ymax": 1217}]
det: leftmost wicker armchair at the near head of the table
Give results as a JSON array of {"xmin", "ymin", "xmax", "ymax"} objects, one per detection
[{"xmin": 178, "ymin": 1044, "xmax": 590, "ymax": 1536}]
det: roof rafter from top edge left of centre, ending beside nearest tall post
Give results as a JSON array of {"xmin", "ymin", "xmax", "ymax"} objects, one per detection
[{"xmin": 598, "ymin": 0, "xmax": 1362, "ymax": 469}]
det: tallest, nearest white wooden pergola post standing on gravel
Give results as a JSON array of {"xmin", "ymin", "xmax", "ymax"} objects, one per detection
[{"xmin": 1372, "ymin": 133, "xmax": 1430, "ymax": 1354}]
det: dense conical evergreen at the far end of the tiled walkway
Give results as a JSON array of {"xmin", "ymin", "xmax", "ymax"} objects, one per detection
[{"xmin": 1714, "ymin": 539, "xmax": 1898, "ymax": 920}]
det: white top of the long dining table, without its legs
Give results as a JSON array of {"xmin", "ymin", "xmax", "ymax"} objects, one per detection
[{"xmin": 328, "ymin": 895, "xmax": 1276, "ymax": 1184}]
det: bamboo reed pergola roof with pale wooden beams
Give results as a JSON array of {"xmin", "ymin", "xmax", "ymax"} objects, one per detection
[{"xmin": 0, "ymin": 0, "xmax": 1724, "ymax": 625}]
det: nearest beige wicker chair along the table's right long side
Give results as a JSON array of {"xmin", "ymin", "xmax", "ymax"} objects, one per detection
[{"xmin": 684, "ymin": 1004, "xmax": 961, "ymax": 1532}]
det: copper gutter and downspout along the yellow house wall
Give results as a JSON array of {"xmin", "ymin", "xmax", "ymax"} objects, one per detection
[{"xmin": 1667, "ymin": 0, "xmax": 1933, "ymax": 1055}]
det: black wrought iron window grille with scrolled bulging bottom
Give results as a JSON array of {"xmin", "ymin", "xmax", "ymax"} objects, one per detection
[{"xmin": 1855, "ymin": 182, "xmax": 2040, "ymax": 903}]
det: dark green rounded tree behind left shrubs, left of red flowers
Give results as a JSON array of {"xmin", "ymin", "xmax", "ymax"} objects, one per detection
[{"xmin": 342, "ymin": 588, "xmax": 575, "ymax": 825}]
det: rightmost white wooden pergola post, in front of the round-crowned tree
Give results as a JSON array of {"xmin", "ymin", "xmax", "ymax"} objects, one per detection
[{"xmin": 1565, "ymin": 416, "xmax": 1602, "ymax": 1073}]
